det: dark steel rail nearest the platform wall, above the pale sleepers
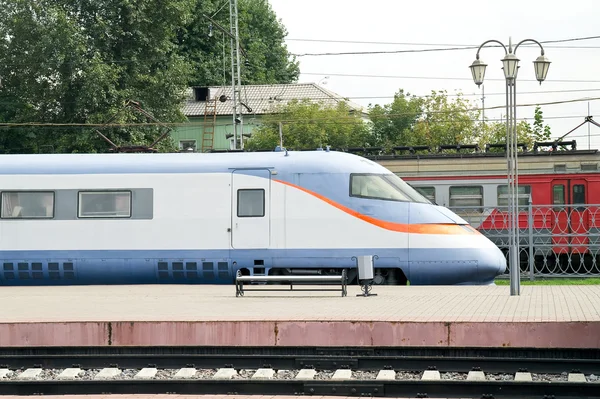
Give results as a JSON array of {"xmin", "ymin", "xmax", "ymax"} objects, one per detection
[{"xmin": 0, "ymin": 347, "xmax": 600, "ymax": 376}]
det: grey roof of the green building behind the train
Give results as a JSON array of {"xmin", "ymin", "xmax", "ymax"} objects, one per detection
[{"xmin": 183, "ymin": 83, "xmax": 366, "ymax": 117}]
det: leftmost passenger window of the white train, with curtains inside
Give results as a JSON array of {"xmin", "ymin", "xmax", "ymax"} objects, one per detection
[{"xmin": 1, "ymin": 191, "xmax": 54, "ymax": 219}]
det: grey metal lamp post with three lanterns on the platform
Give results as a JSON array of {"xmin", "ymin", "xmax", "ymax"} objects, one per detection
[{"xmin": 470, "ymin": 38, "xmax": 550, "ymax": 295}]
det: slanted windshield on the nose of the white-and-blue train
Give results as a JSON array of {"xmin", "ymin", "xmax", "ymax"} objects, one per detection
[{"xmin": 350, "ymin": 173, "xmax": 431, "ymax": 204}]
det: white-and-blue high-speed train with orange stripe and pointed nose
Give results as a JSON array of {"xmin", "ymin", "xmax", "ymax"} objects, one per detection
[{"xmin": 0, "ymin": 149, "xmax": 506, "ymax": 285}]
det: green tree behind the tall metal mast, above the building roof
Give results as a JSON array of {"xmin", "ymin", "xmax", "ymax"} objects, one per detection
[{"xmin": 178, "ymin": 0, "xmax": 300, "ymax": 86}]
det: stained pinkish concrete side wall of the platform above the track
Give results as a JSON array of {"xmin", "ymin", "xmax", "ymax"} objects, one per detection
[{"xmin": 0, "ymin": 321, "xmax": 600, "ymax": 348}]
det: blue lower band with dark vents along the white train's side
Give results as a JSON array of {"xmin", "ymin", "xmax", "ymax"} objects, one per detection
[{"xmin": 0, "ymin": 248, "xmax": 503, "ymax": 285}]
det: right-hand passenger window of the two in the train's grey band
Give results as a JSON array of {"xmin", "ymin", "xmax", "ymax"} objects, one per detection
[{"xmin": 78, "ymin": 191, "xmax": 131, "ymax": 218}]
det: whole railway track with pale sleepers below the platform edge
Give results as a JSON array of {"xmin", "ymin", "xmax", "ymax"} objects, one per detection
[{"xmin": 0, "ymin": 347, "xmax": 600, "ymax": 399}]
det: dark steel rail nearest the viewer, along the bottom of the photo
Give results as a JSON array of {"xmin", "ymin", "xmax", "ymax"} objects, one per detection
[{"xmin": 0, "ymin": 380, "xmax": 600, "ymax": 399}]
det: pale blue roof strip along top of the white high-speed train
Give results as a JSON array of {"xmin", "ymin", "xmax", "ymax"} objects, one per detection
[{"xmin": 0, "ymin": 150, "xmax": 390, "ymax": 175}]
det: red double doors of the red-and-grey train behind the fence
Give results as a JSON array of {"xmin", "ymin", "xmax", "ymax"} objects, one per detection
[{"xmin": 552, "ymin": 179, "xmax": 590, "ymax": 254}]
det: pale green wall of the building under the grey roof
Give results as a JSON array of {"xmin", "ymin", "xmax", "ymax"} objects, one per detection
[{"xmin": 171, "ymin": 115, "xmax": 261, "ymax": 152}]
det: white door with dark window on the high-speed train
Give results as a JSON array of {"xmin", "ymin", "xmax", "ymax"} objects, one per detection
[{"xmin": 231, "ymin": 169, "xmax": 271, "ymax": 249}]
